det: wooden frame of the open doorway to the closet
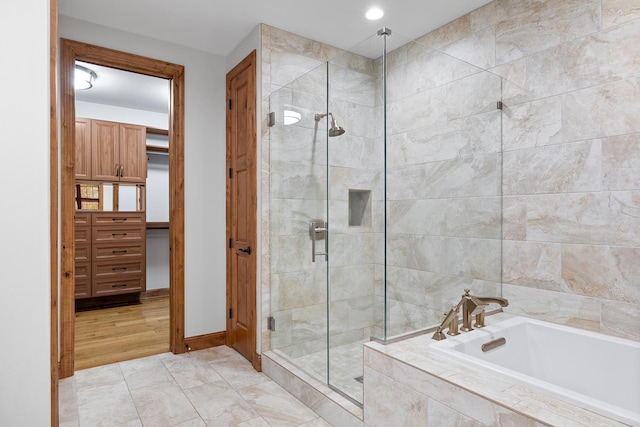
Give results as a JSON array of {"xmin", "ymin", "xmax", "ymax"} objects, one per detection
[{"xmin": 58, "ymin": 39, "xmax": 186, "ymax": 378}]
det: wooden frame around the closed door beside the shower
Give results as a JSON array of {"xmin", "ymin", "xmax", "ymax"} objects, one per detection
[{"xmin": 226, "ymin": 50, "xmax": 262, "ymax": 372}]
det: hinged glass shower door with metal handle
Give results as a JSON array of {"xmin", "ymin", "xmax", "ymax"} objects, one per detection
[{"xmin": 269, "ymin": 64, "xmax": 327, "ymax": 382}]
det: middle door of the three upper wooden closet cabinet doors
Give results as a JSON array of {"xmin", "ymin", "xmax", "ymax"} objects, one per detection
[{"xmin": 91, "ymin": 120, "xmax": 120, "ymax": 181}]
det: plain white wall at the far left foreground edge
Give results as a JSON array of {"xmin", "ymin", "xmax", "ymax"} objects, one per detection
[{"xmin": 0, "ymin": 0, "xmax": 51, "ymax": 426}]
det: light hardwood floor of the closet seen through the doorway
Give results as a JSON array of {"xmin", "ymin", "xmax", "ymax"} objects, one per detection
[{"xmin": 75, "ymin": 296, "xmax": 169, "ymax": 371}]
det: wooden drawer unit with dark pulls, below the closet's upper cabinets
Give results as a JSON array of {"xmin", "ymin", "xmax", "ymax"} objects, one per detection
[{"xmin": 75, "ymin": 212, "xmax": 146, "ymax": 299}]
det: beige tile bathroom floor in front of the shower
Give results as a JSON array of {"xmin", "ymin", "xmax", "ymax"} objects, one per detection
[{"xmin": 60, "ymin": 346, "xmax": 330, "ymax": 427}]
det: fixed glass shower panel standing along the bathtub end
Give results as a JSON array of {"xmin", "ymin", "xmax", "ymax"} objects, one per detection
[{"xmin": 384, "ymin": 34, "xmax": 502, "ymax": 339}]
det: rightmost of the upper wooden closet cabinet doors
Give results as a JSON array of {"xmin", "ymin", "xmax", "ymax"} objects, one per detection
[{"xmin": 120, "ymin": 124, "xmax": 147, "ymax": 182}]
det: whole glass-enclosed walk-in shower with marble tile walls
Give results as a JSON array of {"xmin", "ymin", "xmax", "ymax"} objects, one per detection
[{"xmin": 269, "ymin": 28, "xmax": 503, "ymax": 403}]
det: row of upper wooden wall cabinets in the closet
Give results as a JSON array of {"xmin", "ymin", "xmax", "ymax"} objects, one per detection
[{"xmin": 75, "ymin": 118, "xmax": 147, "ymax": 182}]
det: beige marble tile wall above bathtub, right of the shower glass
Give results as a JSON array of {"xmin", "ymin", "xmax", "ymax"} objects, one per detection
[{"xmin": 484, "ymin": 0, "xmax": 640, "ymax": 340}]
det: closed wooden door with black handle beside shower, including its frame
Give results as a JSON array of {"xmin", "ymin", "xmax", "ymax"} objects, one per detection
[{"xmin": 227, "ymin": 51, "xmax": 260, "ymax": 370}]
